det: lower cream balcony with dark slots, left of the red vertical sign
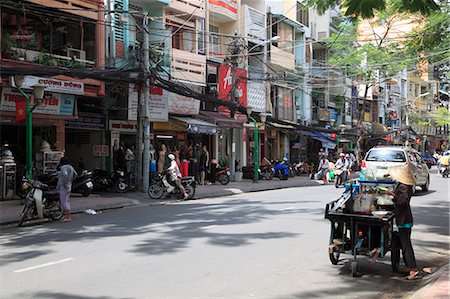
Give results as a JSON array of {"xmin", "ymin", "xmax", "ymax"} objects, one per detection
[{"xmin": 170, "ymin": 48, "xmax": 206, "ymax": 84}]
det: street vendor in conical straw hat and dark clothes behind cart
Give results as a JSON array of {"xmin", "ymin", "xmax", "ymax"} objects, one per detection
[{"xmin": 386, "ymin": 165, "xmax": 421, "ymax": 280}]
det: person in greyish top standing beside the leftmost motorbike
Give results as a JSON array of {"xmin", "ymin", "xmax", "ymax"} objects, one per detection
[{"xmin": 57, "ymin": 157, "xmax": 78, "ymax": 222}]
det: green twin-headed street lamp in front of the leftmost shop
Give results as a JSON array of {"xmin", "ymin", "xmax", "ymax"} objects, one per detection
[{"xmin": 14, "ymin": 75, "xmax": 45, "ymax": 178}]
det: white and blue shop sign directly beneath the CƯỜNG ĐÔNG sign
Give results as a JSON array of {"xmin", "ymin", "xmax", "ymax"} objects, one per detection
[{"xmin": 0, "ymin": 88, "xmax": 75, "ymax": 116}]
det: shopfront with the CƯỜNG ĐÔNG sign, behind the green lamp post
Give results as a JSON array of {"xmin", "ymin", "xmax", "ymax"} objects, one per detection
[{"xmin": 0, "ymin": 76, "xmax": 96, "ymax": 175}]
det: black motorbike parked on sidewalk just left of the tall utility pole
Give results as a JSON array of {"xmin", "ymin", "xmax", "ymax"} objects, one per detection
[{"xmin": 92, "ymin": 168, "xmax": 127, "ymax": 193}]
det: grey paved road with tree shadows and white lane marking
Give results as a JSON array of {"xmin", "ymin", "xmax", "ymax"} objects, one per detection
[{"xmin": 0, "ymin": 170, "xmax": 450, "ymax": 299}]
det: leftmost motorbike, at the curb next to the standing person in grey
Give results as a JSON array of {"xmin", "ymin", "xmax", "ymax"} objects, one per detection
[{"xmin": 18, "ymin": 180, "xmax": 63, "ymax": 226}]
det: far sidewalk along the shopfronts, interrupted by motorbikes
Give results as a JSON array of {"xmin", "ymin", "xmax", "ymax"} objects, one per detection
[{"xmin": 0, "ymin": 176, "xmax": 321, "ymax": 224}]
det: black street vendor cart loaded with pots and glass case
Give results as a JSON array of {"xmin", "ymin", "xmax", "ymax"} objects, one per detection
[{"xmin": 325, "ymin": 181, "xmax": 400, "ymax": 276}]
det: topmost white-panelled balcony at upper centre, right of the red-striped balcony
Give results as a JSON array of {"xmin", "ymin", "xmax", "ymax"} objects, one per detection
[{"xmin": 239, "ymin": 5, "xmax": 267, "ymax": 43}]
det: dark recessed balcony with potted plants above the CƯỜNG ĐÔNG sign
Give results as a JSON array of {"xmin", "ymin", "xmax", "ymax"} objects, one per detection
[{"xmin": 1, "ymin": 7, "xmax": 98, "ymax": 69}]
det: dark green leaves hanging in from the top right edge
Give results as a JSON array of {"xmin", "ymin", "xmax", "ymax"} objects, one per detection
[{"xmin": 307, "ymin": 0, "xmax": 440, "ymax": 19}]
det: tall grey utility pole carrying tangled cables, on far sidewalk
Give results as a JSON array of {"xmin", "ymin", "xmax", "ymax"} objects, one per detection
[{"xmin": 141, "ymin": 12, "xmax": 150, "ymax": 192}]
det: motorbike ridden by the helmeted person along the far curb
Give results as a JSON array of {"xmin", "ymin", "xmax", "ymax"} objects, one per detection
[{"xmin": 148, "ymin": 172, "xmax": 196, "ymax": 199}]
